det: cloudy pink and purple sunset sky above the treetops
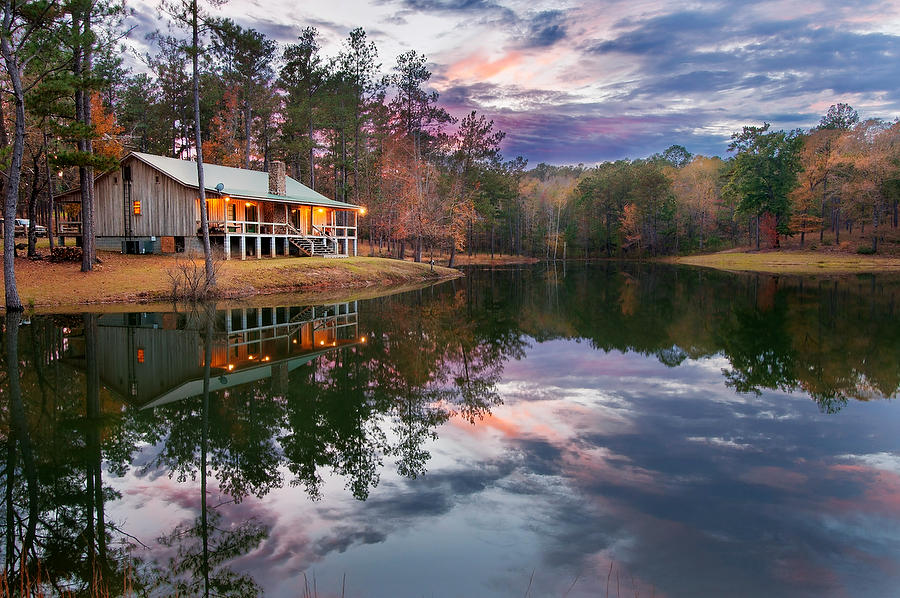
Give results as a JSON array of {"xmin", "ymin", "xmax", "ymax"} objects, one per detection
[{"xmin": 130, "ymin": 0, "xmax": 900, "ymax": 166}]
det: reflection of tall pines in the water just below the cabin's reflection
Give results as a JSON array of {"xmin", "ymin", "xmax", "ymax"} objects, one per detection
[{"xmin": 133, "ymin": 293, "xmax": 523, "ymax": 510}]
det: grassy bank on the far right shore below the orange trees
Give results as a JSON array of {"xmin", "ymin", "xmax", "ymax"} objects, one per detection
[{"xmin": 671, "ymin": 250, "xmax": 900, "ymax": 274}]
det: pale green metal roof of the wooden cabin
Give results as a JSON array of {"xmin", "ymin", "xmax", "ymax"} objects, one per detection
[{"xmin": 130, "ymin": 152, "xmax": 360, "ymax": 209}]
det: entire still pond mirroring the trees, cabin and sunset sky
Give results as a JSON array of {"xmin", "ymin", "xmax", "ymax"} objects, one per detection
[{"xmin": 0, "ymin": 264, "xmax": 900, "ymax": 597}]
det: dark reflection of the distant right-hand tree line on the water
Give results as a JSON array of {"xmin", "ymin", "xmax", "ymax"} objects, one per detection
[{"xmin": 482, "ymin": 263, "xmax": 900, "ymax": 412}]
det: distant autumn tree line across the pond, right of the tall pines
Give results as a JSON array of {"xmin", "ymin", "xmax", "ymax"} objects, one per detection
[{"xmin": 520, "ymin": 104, "xmax": 900, "ymax": 259}]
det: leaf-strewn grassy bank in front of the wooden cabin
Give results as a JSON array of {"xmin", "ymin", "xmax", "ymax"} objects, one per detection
[{"xmin": 5, "ymin": 251, "xmax": 460, "ymax": 308}]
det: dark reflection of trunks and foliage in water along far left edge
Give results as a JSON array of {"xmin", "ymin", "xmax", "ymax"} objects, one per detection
[{"xmin": 3, "ymin": 314, "xmax": 135, "ymax": 594}]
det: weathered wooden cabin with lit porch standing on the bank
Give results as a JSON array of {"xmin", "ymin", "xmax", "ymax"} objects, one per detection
[{"xmin": 55, "ymin": 152, "xmax": 363, "ymax": 259}]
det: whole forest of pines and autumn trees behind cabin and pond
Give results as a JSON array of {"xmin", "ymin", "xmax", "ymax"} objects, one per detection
[{"xmin": 0, "ymin": 0, "xmax": 900, "ymax": 305}]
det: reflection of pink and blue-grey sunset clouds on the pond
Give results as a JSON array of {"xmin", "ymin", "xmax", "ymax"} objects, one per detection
[{"xmin": 103, "ymin": 341, "xmax": 900, "ymax": 597}]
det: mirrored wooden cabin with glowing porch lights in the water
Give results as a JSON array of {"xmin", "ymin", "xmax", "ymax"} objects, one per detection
[{"xmin": 74, "ymin": 301, "xmax": 365, "ymax": 407}]
